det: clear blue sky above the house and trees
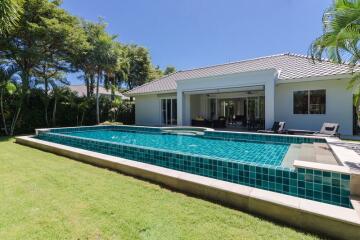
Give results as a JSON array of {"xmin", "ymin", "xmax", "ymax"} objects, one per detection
[{"xmin": 62, "ymin": 0, "xmax": 332, "ymax": 83}]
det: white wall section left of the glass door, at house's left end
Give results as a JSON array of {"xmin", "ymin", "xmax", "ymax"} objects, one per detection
[{"xmin": 135, "ymin": 95, "xmax": 161, "ymax": 126}]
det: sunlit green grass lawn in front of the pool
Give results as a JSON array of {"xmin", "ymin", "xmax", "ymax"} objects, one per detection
[{"xmin": 0, "ymin": 138, "xmax": 317, "ymax": 240}]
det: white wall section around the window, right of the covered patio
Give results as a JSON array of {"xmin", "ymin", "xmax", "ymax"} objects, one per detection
[{"xmin": 276, "ymin": 79, "xmax": 353, "ymax": 135}]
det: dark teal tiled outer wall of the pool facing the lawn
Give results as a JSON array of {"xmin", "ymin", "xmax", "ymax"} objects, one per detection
[{"xmin": 37, "ymin": 126, "xmax": 351, "ymax": 208}]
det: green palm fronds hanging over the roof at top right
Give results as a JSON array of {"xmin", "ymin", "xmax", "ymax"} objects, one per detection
[{"xmin": 309, "ymin": 0, "xmax": 360, "ymax": 66}]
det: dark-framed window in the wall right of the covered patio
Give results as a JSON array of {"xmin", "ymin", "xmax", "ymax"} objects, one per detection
[{"xmin": 294, "ymin": 90, "xmax": 326, "ymax": 114}]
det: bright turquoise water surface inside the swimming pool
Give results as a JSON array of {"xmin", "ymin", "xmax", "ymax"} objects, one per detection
[{"xmin": 63, "ymin": 130, "xmax": 289, "ymax": 166}]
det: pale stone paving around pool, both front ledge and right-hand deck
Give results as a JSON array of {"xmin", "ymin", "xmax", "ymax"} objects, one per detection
[{"xmin": 16, "ymin": 136, "xmax": 360, "ymax": 239}]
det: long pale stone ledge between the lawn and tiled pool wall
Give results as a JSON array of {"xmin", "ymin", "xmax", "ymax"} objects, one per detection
[{"xmin": 15, "ymin": 136, "xmax": 360, "ymax": 239}]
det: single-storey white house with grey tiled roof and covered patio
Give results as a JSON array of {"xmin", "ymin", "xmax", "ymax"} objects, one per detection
[{"xmin": 126, "ymin": 53, "xmax": 357, "ymax": 135}]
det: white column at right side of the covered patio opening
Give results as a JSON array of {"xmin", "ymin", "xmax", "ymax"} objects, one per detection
[{"xmin": 265, "ymin": 79, "xmax": 275, "ymax": 129}]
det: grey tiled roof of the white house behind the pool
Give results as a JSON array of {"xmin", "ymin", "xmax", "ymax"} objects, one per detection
[{"xmin": 125, "ymin": 53, "xmax": 358, "ymax": 95}]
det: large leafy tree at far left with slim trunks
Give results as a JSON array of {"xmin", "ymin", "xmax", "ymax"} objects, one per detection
[{"xmin": 0, "ymin": 0, "xmax": 87, "ymax": 131}]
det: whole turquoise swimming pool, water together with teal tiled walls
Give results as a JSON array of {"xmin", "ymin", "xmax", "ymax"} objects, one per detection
[{"xmin": 36, "ymin": 126, "xmax": 351, "ymax": 207}]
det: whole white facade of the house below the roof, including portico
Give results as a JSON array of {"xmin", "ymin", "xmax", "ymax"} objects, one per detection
[{"xmin": 135, "ymin": 70, "xmax": 353, "ymax": 135}]
